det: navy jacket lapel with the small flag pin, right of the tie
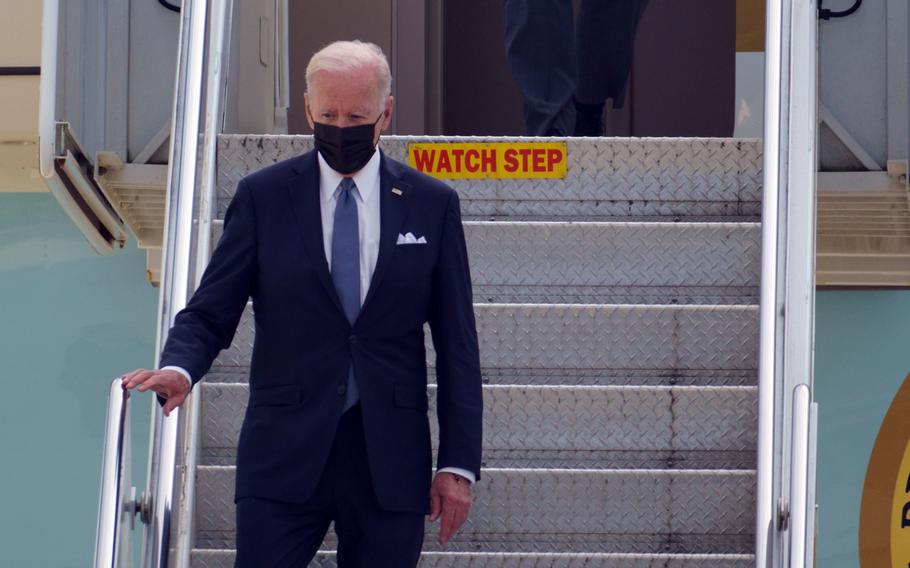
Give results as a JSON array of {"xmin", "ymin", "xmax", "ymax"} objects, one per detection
[{"xmin": 355, "ymin": 152, "xmax": 411, "ymax": 323}]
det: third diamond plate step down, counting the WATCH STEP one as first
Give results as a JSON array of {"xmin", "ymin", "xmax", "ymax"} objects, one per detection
[{"xmin": 215, "ymin": 304, "xmax": 758, "ymax": 373}]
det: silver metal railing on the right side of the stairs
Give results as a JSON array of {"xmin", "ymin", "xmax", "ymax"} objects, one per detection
[{"xmin": 755, "ymin": 0, "xmax": 818, "ymax": 568}]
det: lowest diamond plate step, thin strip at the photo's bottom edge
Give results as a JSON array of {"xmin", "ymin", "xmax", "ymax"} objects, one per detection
[{"xmin": 191, "ymin": 549, "xmax": 755, "ymax": 568}]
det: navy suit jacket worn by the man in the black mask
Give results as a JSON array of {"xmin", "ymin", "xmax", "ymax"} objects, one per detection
[{"xmin": 160, "ymin": 151, "xmax": 483, "ymax": 513}]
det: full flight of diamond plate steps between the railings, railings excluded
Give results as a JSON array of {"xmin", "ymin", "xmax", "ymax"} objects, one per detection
[{"xmin": 188, "ymin": 135, "xmax": 762, "ymax": 568}]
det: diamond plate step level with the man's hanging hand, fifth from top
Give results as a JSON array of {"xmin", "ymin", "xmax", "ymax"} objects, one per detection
[{"xmin": 196, "ymin": 466, "xmax": 755, "ymax": 554}]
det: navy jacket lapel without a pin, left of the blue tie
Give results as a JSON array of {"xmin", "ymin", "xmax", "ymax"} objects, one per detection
[{"xmin": 287, "ymin": 151, "xmax": 344, "ymax": 314}]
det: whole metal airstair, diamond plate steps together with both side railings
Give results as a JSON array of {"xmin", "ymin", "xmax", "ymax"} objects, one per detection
[{"xmin": 94, "ymin": 0, "xmax": 818, "ymax": 568}]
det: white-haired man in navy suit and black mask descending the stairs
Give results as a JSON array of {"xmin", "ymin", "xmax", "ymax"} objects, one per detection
[{"xmin": 124, "ymin": 41, "xmax": 482, "ymax": 568}]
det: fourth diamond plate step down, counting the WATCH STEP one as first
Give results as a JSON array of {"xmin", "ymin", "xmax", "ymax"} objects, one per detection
[{"xmin": 202, "ymin": 383, "xmax": 757, "ymax": 469}]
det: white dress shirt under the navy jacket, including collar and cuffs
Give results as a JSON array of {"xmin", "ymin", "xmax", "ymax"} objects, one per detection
[{"xmin": 161, "ymin": 146, "xmax": 475, "ymax": 483}]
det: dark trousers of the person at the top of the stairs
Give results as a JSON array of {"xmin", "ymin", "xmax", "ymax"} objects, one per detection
[{"xmin": 503, "ymin": 0, "xmax": 647, "ymax": 136}]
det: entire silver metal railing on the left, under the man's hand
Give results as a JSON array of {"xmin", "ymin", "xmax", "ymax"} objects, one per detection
[{"xmin": 95, "ymin": 0, "xmax": 246, "ymax": 567}]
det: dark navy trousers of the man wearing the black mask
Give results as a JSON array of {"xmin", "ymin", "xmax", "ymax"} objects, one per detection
[{"xmin": 235, "ymin": 403, "xmax": 424, "ymax": 568}]
